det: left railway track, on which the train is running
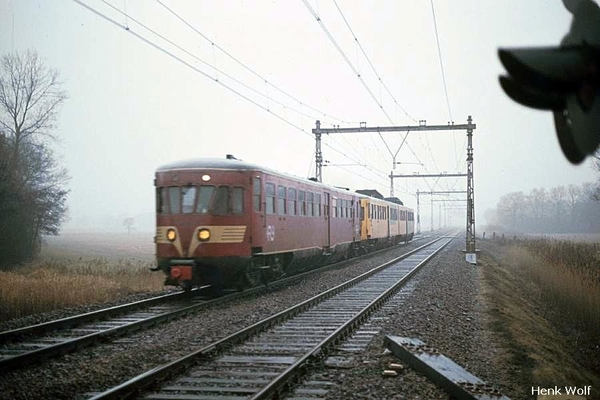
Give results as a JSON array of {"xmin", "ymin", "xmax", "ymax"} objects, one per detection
[{"xmin": 0, "ymin": 236, "xmax": 427, "ymax": 373}]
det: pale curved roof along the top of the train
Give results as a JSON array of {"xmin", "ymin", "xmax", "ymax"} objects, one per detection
[{"xmin": 156, "ymin": 154, "xmax": 412, "ymax": 209}]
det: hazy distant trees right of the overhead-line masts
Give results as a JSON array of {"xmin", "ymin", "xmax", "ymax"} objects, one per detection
[{"xmin": 488, "ymin": 177, "xmax": 600, "ymax": 233}]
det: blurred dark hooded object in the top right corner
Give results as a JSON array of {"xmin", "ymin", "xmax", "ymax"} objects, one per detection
[{"xmin": 498, "ymin": 0, "xmax": 600, "ymax": 164}]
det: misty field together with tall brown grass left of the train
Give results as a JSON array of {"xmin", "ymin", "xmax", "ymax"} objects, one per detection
[{"xmin": 0, "ymin": 232, "xmax": 164, "ymax": 321}]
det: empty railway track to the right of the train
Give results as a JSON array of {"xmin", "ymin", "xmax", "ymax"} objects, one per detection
[{"xmin": 88, "ymin": 236, "xmax": 453, "ymax": 400}]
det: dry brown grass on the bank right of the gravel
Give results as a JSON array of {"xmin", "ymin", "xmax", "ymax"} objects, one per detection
[{"xmin": 480, "ymin": 242, "xmax": 600, "ymax": 398}]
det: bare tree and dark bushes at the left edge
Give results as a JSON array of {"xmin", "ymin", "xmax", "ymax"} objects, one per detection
[{"xmin": 0, "ymin": 51, "xmax": 68, "ymax": 267}]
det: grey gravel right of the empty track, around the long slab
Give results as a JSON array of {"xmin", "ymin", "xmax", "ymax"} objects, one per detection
[{"xmin": 315, "ymin": 239, "xmax": 517, "ymax": 400}]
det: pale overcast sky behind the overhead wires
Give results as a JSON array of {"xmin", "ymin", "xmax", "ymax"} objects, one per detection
[{"xmin": 0, "ymin": 0, "xmax": 597, "ymax": 230}]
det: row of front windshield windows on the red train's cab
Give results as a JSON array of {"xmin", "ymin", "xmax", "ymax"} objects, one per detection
[{"xmin": 156, "ymin": 185, "xmax": 244, "ymax": 215}]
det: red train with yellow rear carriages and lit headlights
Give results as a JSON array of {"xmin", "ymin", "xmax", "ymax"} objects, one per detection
[{"xmin": 155, "ymin": 156, "xmax": 414, "ymax": 291}]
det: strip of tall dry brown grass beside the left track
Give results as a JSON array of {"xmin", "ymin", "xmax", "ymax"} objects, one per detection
[{"xmin": 0, "ymin": 258, "xmax": 163, "ymax": 321}]
